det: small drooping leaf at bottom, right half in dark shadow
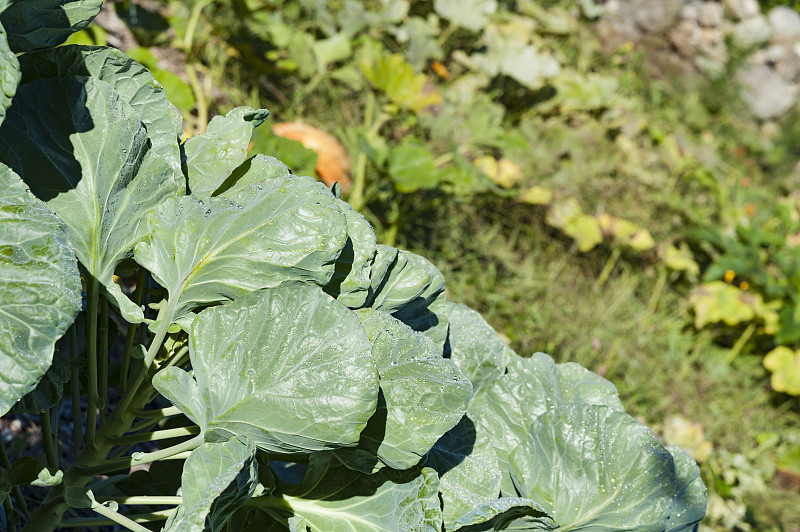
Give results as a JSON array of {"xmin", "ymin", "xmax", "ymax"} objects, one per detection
[{"xmin": 164, "ymin": 437, "xmax": 257, "ymax": 532}]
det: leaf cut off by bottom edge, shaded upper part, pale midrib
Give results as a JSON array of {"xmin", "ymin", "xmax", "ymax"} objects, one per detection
[{"xmin": 276, "ymin": 454, "xmax": 442, "ymax": 532}]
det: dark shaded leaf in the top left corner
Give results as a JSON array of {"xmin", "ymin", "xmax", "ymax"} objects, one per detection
[{"xmin": 0, "ymin": 0, "xmax": 103, "ymax": 53}]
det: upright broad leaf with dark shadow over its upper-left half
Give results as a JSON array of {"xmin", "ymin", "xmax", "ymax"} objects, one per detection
[{"xmin": 0, "ymin": 76, "xmax": 182, "ymax": 322}]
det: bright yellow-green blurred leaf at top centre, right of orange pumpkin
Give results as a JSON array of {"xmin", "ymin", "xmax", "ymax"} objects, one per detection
[{"xmin": 358, "ymin": 54, "xmax": 442, "ymax": 111}]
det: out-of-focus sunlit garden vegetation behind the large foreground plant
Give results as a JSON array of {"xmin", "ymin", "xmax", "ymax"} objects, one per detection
[{"xmin": 51, "ymin": 0, "xmax": 800, "ymax": 532}]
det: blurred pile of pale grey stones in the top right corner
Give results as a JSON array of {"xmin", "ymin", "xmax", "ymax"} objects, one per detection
[{"xmin": 596, "ymin": 0, "xmax": 800, "ymax": 120}]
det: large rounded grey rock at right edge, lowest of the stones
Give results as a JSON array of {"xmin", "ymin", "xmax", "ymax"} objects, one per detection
[{"xmin": 737, "ymin": 65, "xmax": 798, "ymax": 120}]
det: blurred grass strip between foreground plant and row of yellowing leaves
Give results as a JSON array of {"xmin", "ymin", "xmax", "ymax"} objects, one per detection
[{"xmin": 412, "ymin": 200, "xmax": 800, "ymax": 531}]
